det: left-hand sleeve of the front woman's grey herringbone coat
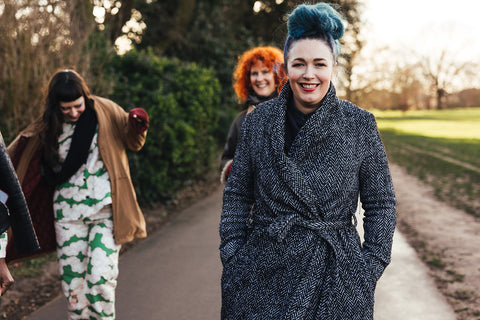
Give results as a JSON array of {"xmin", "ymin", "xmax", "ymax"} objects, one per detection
[{"xmin": 220, "ymin": 117, "xmax": 254, "ymax": 265}]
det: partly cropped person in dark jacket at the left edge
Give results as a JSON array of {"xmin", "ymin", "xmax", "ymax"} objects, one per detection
[{"xmin": 0, "ymin": 133, "xmax": 40, "ymax": 296}]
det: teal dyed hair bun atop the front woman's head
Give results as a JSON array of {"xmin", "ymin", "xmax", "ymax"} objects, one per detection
[{"xmin": 288, "ymin": 3, "xmax": 345, "ymax": 40}]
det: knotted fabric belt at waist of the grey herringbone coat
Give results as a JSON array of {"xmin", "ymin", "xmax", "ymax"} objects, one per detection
[{"xmin": 253, "ymin": 213, "xmax": 354, "ymax": 242}]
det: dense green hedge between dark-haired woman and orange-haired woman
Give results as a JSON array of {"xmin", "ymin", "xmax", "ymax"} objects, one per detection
[{"xmin": 111, "ymin": 51, "xmax": 220, "ymax": 205}]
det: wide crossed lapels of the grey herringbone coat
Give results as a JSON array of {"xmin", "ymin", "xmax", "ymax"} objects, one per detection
[{"xmin": 262, "ymin": 82, "xmax": 341, "ymax": 218}]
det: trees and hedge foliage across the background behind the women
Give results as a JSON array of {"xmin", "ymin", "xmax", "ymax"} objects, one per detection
[{"xmin": 0, "ymin": 0, "xmax": 480, "ymax": 205}]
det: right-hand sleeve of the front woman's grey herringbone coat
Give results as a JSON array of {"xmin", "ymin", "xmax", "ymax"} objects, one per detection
[{"xmin": 359, "ymin": 114, "xmax": 396, "ymax": 281}]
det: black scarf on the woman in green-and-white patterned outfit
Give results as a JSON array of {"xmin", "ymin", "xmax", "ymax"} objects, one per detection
[{"xmin": 42, "ymin": 107, "xmax": 97, "ymax": 186}]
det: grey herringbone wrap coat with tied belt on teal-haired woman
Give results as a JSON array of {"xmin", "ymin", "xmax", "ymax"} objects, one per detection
[{"xmin": 220, "ymin": 83, "xmax": 396, "ymax": 320}]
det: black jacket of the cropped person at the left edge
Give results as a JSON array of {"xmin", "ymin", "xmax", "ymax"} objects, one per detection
[{"xmin": 0, "ymin": 134, "xmax": 40, "ymax": 258}]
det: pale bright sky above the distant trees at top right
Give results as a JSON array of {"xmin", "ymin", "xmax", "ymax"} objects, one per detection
[{"xmin": 361, "ymin": 0, "xmax": 480, "ymax": 61}]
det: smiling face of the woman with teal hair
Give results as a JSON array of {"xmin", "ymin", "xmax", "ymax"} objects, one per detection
[{"xmin": 287, "ymin": 39, "xmax": 335, "ymax": 113}]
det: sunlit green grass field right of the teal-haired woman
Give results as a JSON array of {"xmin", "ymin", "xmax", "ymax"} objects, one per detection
[{"xmin": 374, "ymin": 108, "xmax": 480, "ymax": 217}]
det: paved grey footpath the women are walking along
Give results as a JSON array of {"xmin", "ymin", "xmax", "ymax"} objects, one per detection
[{"xmin": 26, "ymin": 189, "xmax": 456, "ymax": 320}]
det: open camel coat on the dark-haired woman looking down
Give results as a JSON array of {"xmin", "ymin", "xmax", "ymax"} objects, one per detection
[{"xmin": 7, "ymin": 96, "xmax": 147, "ymax": 259}]
